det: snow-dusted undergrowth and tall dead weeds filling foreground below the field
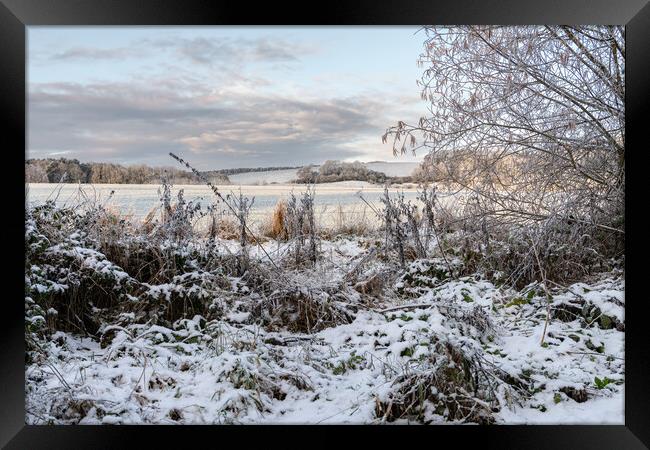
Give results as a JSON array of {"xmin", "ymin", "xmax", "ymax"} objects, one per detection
[{"xmin": 25, "ymin": 178, "xmax": 625, "ymax": 424}]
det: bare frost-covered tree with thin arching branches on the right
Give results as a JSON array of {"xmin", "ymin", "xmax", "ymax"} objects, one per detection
[{"xmin": 383, "ymin": 26, "xmax": 625, "ymax": 236}]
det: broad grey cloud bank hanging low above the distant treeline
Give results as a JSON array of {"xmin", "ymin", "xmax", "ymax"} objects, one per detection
[{"xmin": 28, "ymin": 80, "xmax": 383, "ymax": 169}]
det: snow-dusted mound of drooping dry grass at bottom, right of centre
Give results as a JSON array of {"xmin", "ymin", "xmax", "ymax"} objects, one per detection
[{"xmin": 375, "ymin": 296, "xmax": 520, "ymax": 424}]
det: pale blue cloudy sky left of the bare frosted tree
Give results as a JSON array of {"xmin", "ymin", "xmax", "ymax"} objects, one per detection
[{"xmin": 27, "ymin": 27, "xmax": 426, "ymax": 170}]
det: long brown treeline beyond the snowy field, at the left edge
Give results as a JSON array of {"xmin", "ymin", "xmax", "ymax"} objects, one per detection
[{"xmin": 25, "ymin": 158, "xmax": 230, "ymax": 184}]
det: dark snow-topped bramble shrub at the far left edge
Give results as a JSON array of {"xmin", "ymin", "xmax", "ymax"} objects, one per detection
[{"xmin": 25, "ymin": 203, "xmax": 137, "ymax": 333}]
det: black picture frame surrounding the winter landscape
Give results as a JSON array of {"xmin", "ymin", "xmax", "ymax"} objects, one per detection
[{"xmin": 0, "ymin": 0, "xmax": 650, "ymax": 449}]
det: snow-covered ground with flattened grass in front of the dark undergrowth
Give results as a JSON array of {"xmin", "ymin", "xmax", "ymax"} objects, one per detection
[{"xmin": 26, "ymin": 234, "xmax": 625, "ymax": 424}]
